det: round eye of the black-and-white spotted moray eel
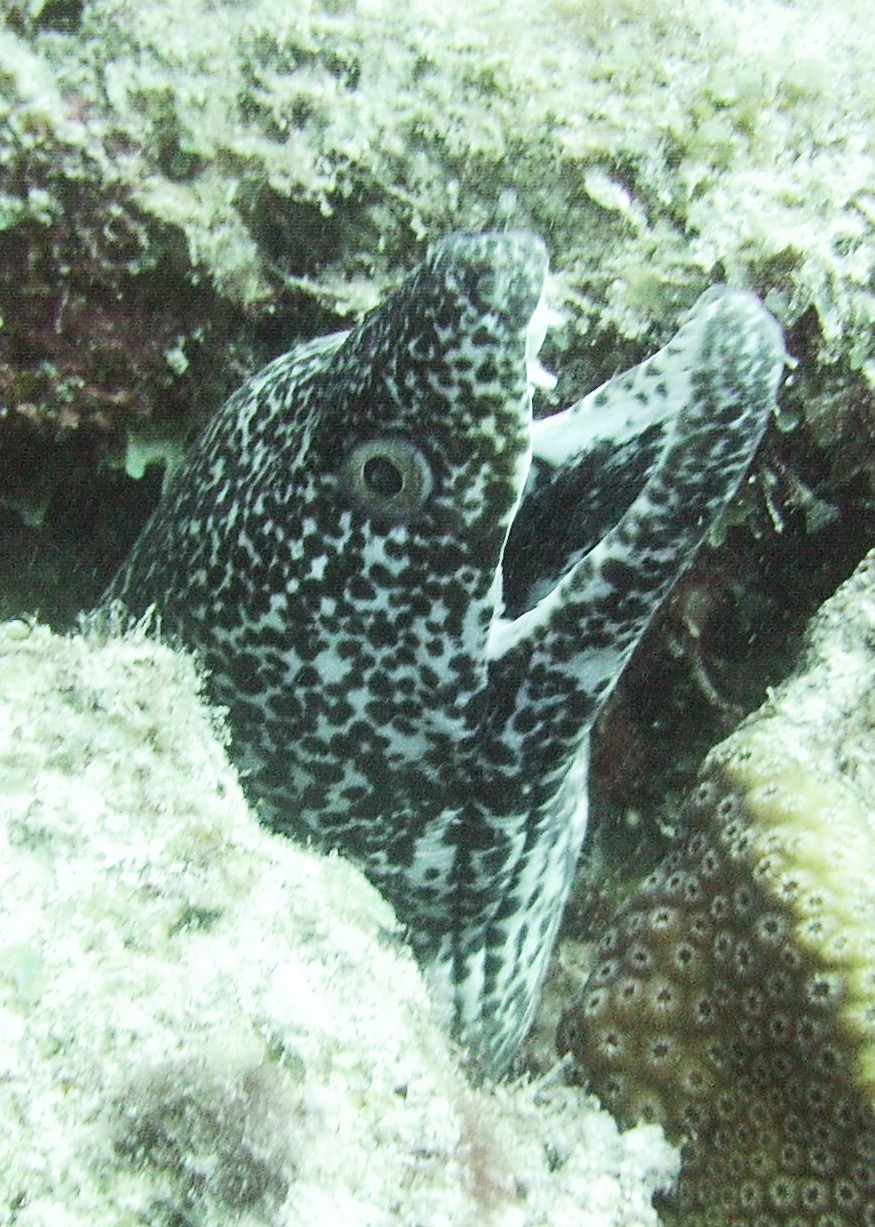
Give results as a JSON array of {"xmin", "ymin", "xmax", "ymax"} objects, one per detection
[{"xmin": 341, "ymin": 436, "xmax": 432, "ymax": 520}]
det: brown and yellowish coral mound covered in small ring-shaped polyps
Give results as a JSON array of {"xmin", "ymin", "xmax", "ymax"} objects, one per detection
[{"xmin": 560, "ymin": 552, "xmax": 875, "ymax": 1227}]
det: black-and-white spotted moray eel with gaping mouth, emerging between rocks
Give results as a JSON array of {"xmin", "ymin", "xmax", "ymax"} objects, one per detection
[{"xmin": 107, "ymin": 233, "xmax": 784, "ymax": 1079}]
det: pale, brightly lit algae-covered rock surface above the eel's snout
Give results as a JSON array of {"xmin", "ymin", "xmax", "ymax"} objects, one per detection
[{"xmin": 2, "ymin": 0, "xmax": 875, "ymax": 407}]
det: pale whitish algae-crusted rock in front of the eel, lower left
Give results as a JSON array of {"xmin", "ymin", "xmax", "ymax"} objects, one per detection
[{"xmin": 0, "ymin": 621, "xmax": 676, "ymax": 1227}]
